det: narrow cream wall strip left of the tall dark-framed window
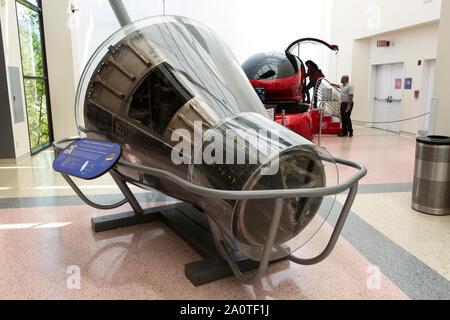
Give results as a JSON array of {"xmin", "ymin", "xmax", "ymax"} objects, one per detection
[{"xmin": 0, "ymin": 0, "xmax": 30, "ymax": 158}]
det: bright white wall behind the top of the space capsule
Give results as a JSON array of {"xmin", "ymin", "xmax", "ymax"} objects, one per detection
[{"xmin": 74, "ymin": 0, "xmax": 330, "ymax": 71}]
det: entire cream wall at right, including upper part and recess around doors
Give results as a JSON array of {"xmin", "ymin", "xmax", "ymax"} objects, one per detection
[{"xmin": 328, "ymin": 0, "xmax": 442, "ymax": 133}]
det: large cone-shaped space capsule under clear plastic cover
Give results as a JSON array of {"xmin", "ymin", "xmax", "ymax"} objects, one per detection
[{"xmin": 76, "ymin": 16, "xmax": 340, "ymax": 260}]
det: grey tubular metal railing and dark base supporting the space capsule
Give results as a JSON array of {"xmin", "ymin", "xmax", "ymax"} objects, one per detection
[{"xmin": 53, "ymin": 137, "xmax": 367, "ymax": 286}]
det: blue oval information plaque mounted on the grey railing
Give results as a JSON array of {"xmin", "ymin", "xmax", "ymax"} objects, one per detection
[{"xmin": 53, "ymin": 139, "xmax": 122, "ymax": 180}]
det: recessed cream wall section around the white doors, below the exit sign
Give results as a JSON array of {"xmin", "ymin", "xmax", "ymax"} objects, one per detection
[{"xmin": 351, "ymin": 22, "xmax": 439, "ymax": 134}]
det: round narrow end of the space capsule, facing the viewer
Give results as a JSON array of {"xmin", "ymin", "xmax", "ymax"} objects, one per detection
[{"xmin": 234, "ymin": 147, "xmax": 326, "ymax": 247}]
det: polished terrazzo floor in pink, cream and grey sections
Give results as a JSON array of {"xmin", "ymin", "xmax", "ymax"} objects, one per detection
[{"xmin": 0, "ymin": 128, "xmax": 450, "ymax": 300}]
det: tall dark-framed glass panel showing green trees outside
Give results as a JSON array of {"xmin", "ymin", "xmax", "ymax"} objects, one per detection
[{"xmin": 16, "ymin": 0, "xmax": 53, "ymax": 155}]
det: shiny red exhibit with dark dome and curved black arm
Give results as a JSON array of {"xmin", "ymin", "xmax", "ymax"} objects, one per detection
[{"xmin": 242, "ymin": 38, "xmax": 342, "ymax": 140}]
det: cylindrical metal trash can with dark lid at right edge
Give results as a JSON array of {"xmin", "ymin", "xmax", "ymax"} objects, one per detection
[{"xmin": 412, "ymin": 136, "xmax": 450, "ymax": 216}]
